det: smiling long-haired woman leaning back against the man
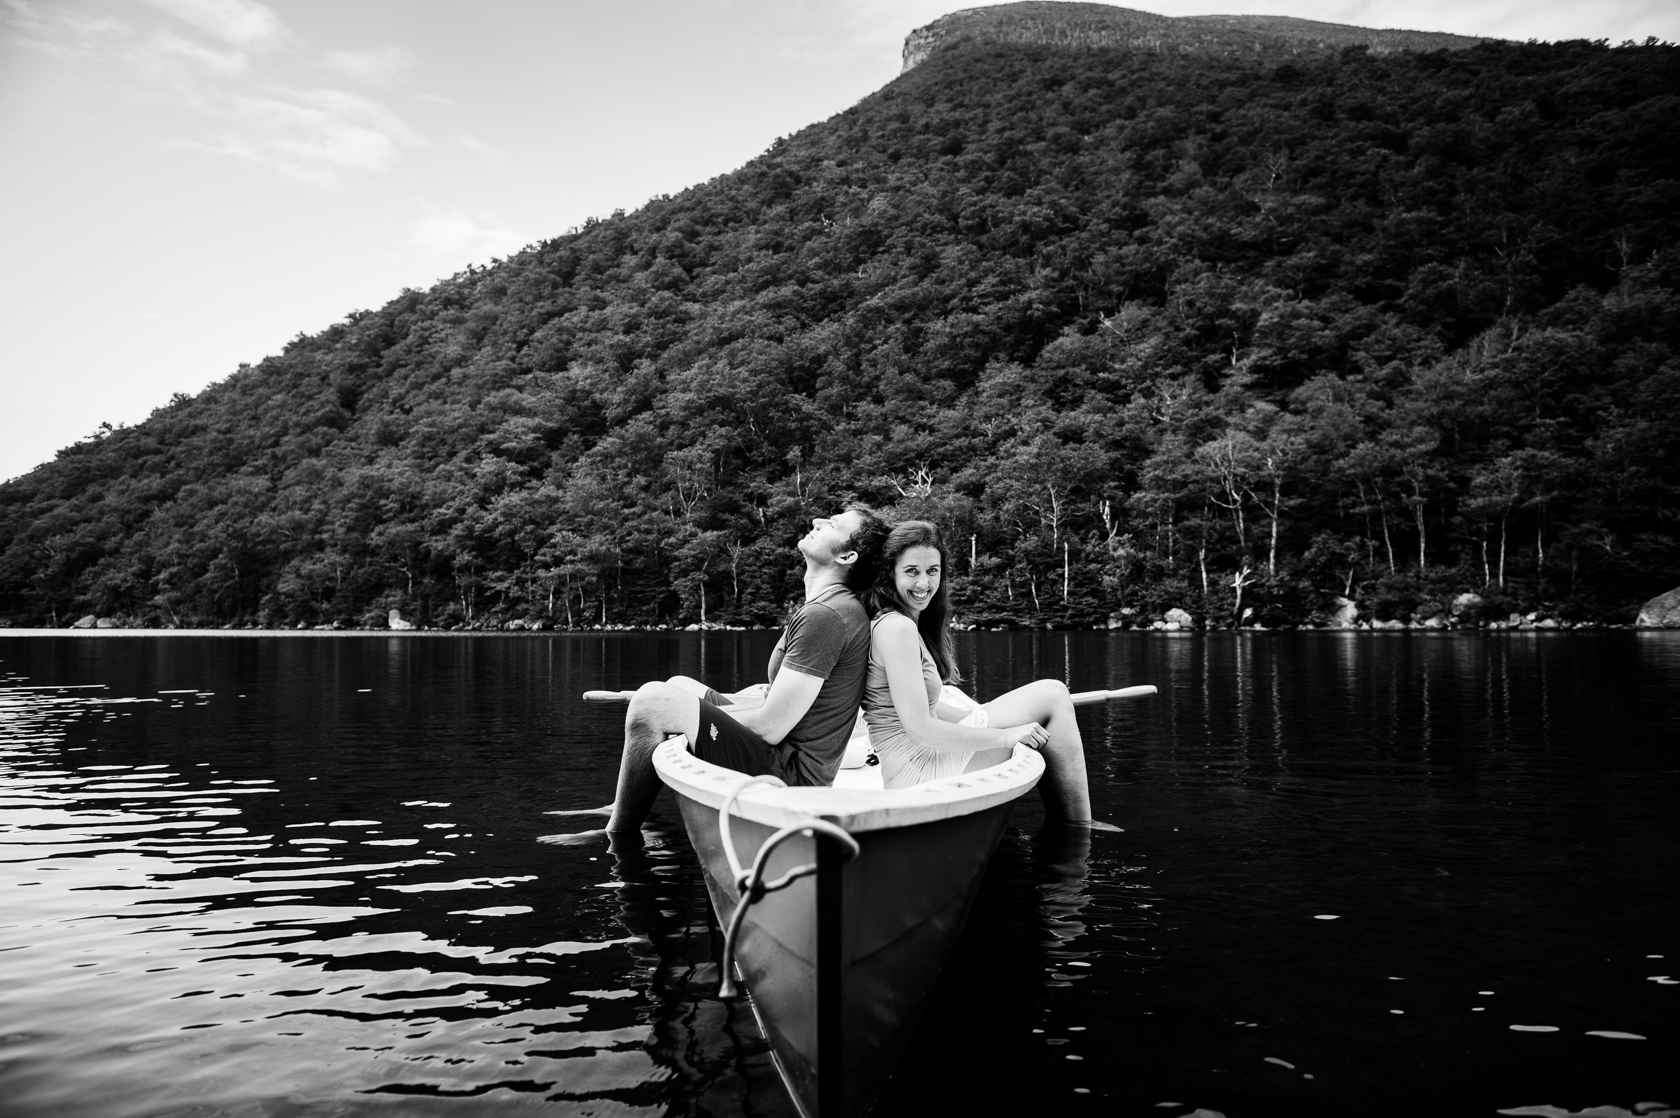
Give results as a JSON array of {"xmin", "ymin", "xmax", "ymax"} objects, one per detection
[{"xmin": 864, "ymin": 519, "xmax": 1109, "ymax": 829}]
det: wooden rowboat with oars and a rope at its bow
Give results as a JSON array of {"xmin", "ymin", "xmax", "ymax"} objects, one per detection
[{"xmin": 628, "ymin": 686, "xmax": 1154, "ymax": 1118}]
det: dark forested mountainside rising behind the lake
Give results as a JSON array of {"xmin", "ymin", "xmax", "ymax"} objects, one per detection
[{"xmin": 0, "ymin": 34, "xmax": 1680, "ymax": 625}]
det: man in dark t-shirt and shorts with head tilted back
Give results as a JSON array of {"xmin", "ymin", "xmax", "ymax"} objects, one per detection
[{"xmin": 600, "ymin": 506, "xmax": 887, "ymax": 832}]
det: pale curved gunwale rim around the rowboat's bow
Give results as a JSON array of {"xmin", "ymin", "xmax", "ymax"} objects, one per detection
[{"xmin": 654, "ymin": 735, "xmax": 1045, "ymax": 834}]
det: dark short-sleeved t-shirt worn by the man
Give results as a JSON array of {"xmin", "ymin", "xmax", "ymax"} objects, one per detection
[{"xmin": 769, "ymin": 587, "xmax": 869, "ymax": 785}]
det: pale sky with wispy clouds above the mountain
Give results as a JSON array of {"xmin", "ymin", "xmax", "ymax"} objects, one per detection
[{"xmin": 0, "ymin": 0, "xmax": 1680, "ymax": 481}]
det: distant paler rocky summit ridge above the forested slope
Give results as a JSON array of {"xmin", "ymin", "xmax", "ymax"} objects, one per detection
[{"xmin": 904, "ymin": 0, "xmax": 1485, "ymax": 71}]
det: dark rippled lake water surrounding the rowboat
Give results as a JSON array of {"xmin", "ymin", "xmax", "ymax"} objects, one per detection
[{"xmin": 0, "ymin": 632, "xmax": 1680, "ymax": 1118}]
